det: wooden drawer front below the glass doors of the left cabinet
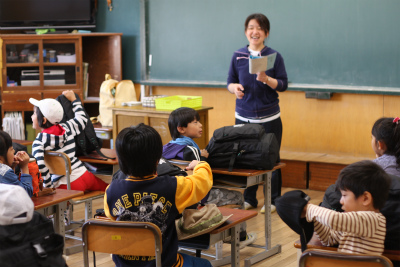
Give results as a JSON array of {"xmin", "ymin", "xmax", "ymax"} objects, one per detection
[{"xmin": 2, "ymin": 92, "xmax": 42, "ymax": 112}]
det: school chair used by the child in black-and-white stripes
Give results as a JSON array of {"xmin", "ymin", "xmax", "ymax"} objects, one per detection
[{"xmin": 44, "ymin": 151, "xmax": 104, "ymax": 255}]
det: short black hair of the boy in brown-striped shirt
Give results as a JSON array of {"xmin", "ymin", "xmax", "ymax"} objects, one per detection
[{"xmin": 336, "ymin": 160, "xmax": 391, "ymax": 209}]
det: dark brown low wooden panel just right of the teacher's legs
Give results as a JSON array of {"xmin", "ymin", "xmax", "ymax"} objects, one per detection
[{"xmin": 281, "ymin": 160, "xmax": 308, "ymax": 189}]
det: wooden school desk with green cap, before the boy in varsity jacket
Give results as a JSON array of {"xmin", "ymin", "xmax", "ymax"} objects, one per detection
[{"xmin": 178, "ymin": 207, "xmax": 258, "ymax": 267}]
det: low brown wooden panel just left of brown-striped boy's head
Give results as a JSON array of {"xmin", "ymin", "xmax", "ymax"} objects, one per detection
[{"xmin": 308, "ymin": 162, "xmax": 347, "ymax": 191}]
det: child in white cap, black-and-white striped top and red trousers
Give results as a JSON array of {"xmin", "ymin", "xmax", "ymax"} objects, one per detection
[{"xmin": 29, "ymin": 90, "xmax": 108, "ymax": 191}]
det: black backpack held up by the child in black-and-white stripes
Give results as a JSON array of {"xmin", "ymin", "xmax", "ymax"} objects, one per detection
[{"xmin": 56, "ymin": 94, "xmax": 114, "ymax": 160}]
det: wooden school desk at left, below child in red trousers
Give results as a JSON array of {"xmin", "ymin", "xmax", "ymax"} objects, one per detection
[{"xmin": 32, "ymin": 189, "xmax": 83, "ymax": 252}]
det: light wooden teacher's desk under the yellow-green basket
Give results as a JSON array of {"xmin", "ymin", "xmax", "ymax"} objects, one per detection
[{"xmin": 112, "ymin": 106, "xmax": 212, "ymax": 149}]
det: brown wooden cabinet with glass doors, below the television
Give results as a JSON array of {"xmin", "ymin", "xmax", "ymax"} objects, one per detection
[{"xmin": 0, "ymin": 33, "xmax": 122, "ymax": 120}]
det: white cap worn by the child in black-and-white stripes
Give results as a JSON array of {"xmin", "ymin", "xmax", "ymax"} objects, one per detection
[{"xmin": 29, "ymin": 98, "xmax": 64, "ymax": 124}]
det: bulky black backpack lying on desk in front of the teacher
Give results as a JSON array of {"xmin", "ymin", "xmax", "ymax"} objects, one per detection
[{"xmin": 206, "ymin": 123, "xmax": 279, "ymax": 171}]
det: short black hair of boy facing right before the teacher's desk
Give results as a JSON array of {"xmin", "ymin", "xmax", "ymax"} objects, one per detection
[{"xmin": 168, "ymin": 107, "xmax": 200, "ymax": 140}]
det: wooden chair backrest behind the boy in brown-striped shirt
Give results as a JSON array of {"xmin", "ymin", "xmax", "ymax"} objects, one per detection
[{"xmin": 299, "ymin": 249, "xmax": 393, "ymax": 267}]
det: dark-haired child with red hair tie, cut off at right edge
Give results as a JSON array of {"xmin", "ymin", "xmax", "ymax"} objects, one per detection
[{"xmin": 371, "ymin": 117, "xmax": 400, "ymax": 177}]
